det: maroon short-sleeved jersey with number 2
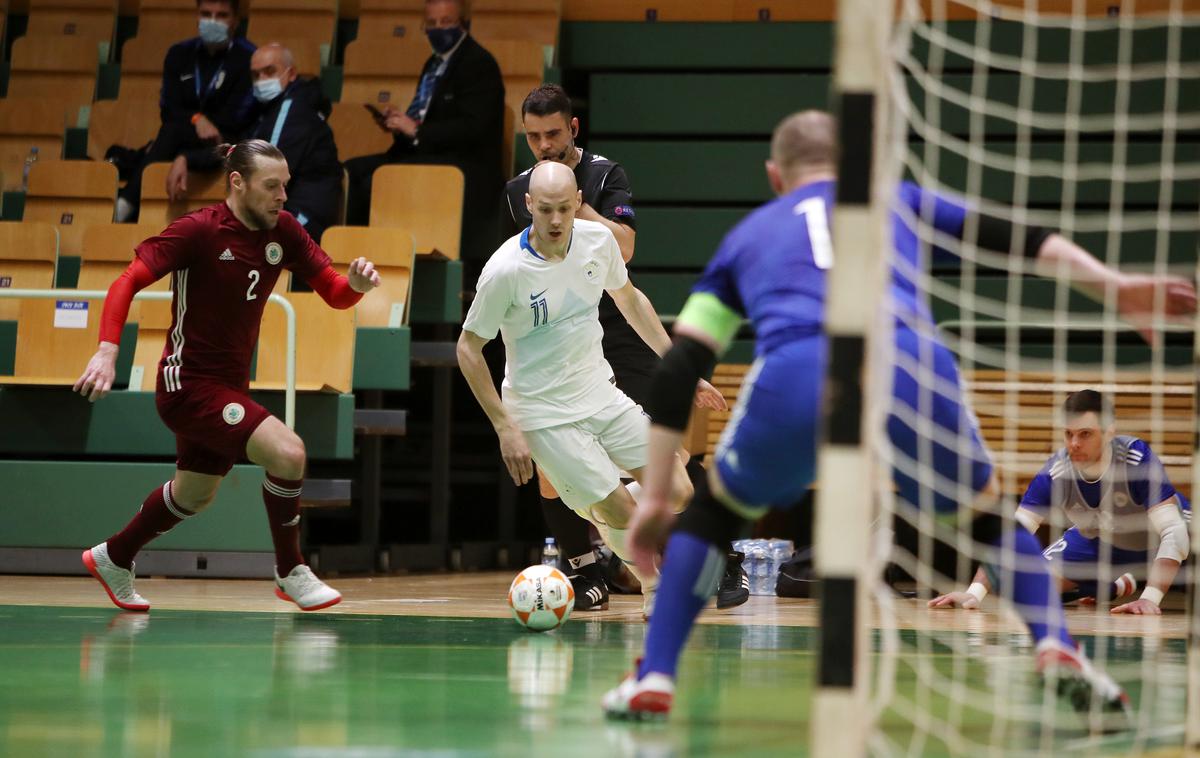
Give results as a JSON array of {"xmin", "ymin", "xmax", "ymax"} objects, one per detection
[{"xmin": 137, "ymin": 203, "xmax": 330, "ymax": 392}]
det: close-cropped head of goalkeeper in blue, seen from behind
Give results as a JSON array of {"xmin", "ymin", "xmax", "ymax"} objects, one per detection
[{"xmin": 767, "ymin": 110, "xmax": 838, "ymax": 194}]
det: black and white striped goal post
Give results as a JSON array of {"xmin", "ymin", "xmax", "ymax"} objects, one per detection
[{"xmin": 811, "ymin": 0, "xmax": 894, "ymax": 758}]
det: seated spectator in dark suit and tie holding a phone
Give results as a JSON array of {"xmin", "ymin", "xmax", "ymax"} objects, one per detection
[{"xmin": 346, "ymin": 0, "xmax": 504, "ymax": 260}]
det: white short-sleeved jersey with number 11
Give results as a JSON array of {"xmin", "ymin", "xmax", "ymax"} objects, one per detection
[{"xmin": 462, "ymin": 219, "xmax": 629, "ymax": 431}]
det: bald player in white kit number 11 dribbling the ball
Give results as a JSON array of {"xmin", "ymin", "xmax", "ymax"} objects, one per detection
[{"xmin": 457, "ymin": 162, "xmax": 726, "ymax": 614}]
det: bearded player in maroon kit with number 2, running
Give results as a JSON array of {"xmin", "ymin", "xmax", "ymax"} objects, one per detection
[{"xmin": 74, "ymin": 139, "xmax": 379, "ymax": 610}]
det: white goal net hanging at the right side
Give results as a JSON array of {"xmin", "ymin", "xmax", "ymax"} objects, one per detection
[{"xmin": 869, "ymin": 0, "xmax": 1200, "ymax": 756}]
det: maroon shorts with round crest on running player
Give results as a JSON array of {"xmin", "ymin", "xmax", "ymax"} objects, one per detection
[{"xmin": 155, "ymin": 379, "xmax": 271, "ymax": 476}]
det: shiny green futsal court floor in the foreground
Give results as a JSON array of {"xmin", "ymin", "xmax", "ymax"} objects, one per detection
[{"xmin": 0, "ymin": 606, "xmax": 1186, "ymax": 758}]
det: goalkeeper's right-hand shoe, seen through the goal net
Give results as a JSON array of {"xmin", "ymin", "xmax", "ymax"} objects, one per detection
[{"xmin": 1037, "ymin": 637, "xmax": 1132, "ymax": 732}]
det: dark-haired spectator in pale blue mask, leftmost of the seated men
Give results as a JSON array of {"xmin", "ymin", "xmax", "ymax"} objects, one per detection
[{"xmin": 116, "ymin": 0, "xmax": 254, "ymax": 221}]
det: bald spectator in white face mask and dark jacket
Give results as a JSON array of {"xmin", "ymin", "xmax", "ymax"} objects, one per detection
[{"xmin": 167, "ymin": 42, "xmax": 342, "ymax": 242}]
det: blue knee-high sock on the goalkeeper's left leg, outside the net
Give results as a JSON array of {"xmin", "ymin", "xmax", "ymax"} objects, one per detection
[{"xmin": 637, "ymin": 531, "xmax": 727, "ymax": 678}]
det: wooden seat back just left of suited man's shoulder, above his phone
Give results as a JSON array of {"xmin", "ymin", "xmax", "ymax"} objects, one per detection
[{"xmin": 341, "ymin": 35, "xmax": 430, "ymax": 108}]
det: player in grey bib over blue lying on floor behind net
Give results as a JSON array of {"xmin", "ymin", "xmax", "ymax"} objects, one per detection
[{"xmin": 929, "ymin": 390, "xmax": 1192, "ymax": 615}]
